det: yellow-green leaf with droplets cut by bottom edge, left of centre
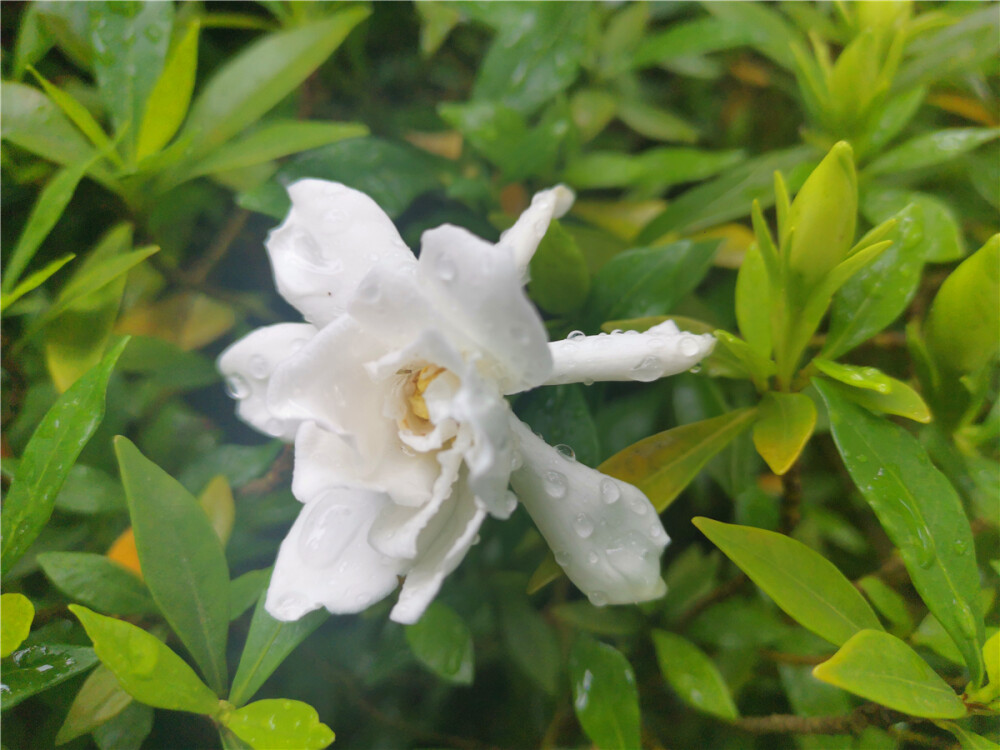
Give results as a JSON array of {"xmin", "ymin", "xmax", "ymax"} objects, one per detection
[{"xmin": 224, "ymin": 699, "xmax": 334, "ymax": 750}]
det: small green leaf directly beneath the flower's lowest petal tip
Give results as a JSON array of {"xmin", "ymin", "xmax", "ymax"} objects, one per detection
[{"xmin": 406, "ymin": 602, "xmax": 474, "ymax": 685}]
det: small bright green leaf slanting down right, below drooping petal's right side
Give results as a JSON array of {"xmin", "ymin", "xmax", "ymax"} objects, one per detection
[{"xmin": 652, "ymin": 630, "xmax": 739, "ymax": 719}]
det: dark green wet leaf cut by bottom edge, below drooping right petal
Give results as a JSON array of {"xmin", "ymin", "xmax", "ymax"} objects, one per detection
[{"xmin": 569, "ymin": 636, "xmax": 640, "ymax": 750}]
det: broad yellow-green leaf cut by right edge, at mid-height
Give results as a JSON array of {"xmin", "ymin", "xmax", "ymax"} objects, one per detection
[{"xmin": 926, "ymin": 234, "xmax": 1000, "ymax": 373}]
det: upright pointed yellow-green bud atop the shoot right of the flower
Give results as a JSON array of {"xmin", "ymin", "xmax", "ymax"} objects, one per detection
[{"xmin": 782, "ymin": 141, "xmax": 858, "ymax": 295}]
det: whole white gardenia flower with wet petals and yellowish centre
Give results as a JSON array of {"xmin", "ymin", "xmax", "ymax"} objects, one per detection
[{"xmin": 219, "ymin": 180, "xmax": 714, "ymax": 623}]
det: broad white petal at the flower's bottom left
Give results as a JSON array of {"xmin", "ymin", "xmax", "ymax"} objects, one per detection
[{"xmin": 264, "ymin": 488, "xmax": 406, "ymax": 621}]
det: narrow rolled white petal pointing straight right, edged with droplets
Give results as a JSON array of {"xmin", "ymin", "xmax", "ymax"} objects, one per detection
[{"xmin": 545, "ymin": 320, "xmax": 715, "ymax": 385}]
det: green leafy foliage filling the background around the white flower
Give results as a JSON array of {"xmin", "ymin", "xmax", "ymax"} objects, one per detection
[{"xmin": 0, "ymin": 0, "xmax": 1000, "ymax": 750}]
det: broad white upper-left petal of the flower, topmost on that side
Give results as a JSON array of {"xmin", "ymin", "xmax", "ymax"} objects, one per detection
[{"xmin": 267, "ymin": 180, "xmax": 415, "ymax": 325}]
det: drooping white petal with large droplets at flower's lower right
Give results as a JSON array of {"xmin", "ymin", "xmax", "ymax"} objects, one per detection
[{"xmin": 511, "ymin": 417, "xmax": 669, "ymax": 606}]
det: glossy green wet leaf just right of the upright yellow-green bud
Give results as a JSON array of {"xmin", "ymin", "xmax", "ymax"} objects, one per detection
[{"xmin": 823, "ymin": 206, "xmax": 926, "ymax": 359}]
